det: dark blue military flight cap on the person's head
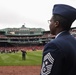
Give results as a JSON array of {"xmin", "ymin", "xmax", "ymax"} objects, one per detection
[{"xmin": 53, "ymin": 4, "xmax": 76, "ymax": 22}]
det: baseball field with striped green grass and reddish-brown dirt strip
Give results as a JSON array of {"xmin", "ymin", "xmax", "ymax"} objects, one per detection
[{"xmin": 0, "ymin": 50, "xmax": 42, "ymax": 75}]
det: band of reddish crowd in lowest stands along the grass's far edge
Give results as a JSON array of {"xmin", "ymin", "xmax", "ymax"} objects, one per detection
[{"xmin": 0, "ymin": 46, "xmax": 43, "ymax": 53}]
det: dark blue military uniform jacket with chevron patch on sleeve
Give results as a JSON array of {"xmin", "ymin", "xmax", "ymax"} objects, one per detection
[{"xmin": 40, "ymin": 31, "xmax": 76, "ymax": 75}]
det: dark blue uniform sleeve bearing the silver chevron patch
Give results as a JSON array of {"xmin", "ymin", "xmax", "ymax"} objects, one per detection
[{"xmin": 40, "ymin": 43, "xmax": 64, "ymax": 75}]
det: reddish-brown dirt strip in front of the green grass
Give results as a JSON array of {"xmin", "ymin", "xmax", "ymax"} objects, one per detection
[{"xmin": 0, "ymin": 66, "xmax": 41, "ymax": 75}]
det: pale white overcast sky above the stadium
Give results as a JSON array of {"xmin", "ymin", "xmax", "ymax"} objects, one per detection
[{"xmin": 0, "ymin": 0, "xmax": 76, "ymax": 30}]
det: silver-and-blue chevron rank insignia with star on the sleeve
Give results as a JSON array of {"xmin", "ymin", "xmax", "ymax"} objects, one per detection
[{"xmin": 41, "ymin": 53, "xmax": 54, "ymax": 75}]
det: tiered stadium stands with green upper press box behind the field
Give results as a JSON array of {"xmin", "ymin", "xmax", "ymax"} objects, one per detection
[{"xmin": 0, "ymin": 25, "xmax": 54, "ymax": 50}]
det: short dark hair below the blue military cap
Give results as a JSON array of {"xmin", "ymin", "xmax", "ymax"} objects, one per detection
[{"xmin": 53, "ymin": 14, "xmax": 72, "ymax": 30}]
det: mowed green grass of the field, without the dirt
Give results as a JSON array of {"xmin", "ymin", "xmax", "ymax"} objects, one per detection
[{"xmin": 0, "ymin": 51, "xmax": 42, "ymax": 66}]
